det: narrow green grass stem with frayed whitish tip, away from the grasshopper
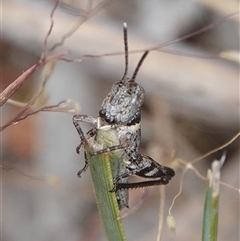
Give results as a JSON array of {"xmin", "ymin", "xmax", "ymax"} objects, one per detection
[{"xmin": 202, "ymin": 161, "xmax": 220, "ymax": 241}]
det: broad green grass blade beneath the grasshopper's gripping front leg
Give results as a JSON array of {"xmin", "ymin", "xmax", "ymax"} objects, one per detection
[{"xmin": 86, "ymin": 149, "xmax": 126, "ymax": 241}]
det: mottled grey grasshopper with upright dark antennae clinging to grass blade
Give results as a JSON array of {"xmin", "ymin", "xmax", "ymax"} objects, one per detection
[{"xmin": 73, "ymin": 23, "xmax": 175, "ymax": 210}]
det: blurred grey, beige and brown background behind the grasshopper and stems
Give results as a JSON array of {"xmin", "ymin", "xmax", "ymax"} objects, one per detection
[{"xmin": 1, "ymin": 0, "xmax": 240, "ymax": 241}]
